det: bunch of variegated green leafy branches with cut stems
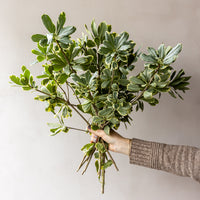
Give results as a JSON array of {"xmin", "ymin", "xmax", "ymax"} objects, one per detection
[{"xmin": 10, "ymin": 12, "xmax": 190, "ymax": 193}]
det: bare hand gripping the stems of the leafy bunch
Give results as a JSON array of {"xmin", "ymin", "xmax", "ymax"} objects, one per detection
[{"xmin": 88, "ymin": 126, "xmax": 131, "ymax": 155}]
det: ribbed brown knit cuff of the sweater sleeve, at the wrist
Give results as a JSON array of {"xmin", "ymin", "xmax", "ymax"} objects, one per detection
[{"xmin": 129, "ymin": 138, "xmax": 163, "ymax": 169}]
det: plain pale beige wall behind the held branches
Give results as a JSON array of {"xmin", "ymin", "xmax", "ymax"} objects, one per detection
[{"xmin": 0, "ymin": 0, "xmax": 200, "ymax": 200}]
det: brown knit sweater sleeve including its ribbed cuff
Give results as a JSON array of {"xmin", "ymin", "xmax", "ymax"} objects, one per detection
[{"xmin": 129, "ymin": 138, "xmax": 200, "ymax": 183}]
